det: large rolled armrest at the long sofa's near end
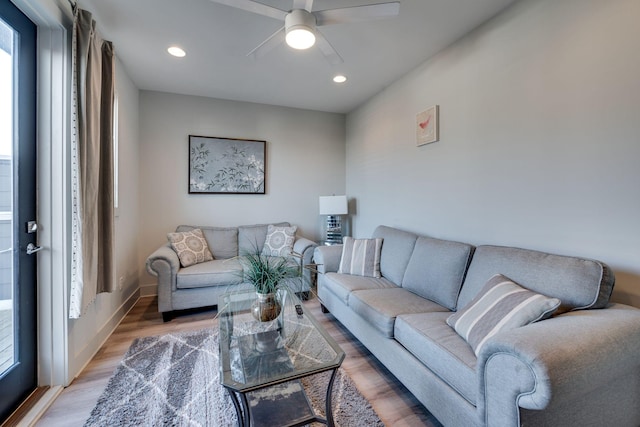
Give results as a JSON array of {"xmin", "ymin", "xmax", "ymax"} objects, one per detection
[{"xmin": 477, "ymin": 304, "xmax": 640, "ymax": 426}]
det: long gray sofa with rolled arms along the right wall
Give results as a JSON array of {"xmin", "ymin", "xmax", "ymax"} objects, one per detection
[{"xmin": 314, "ymin": 226, "xmax": 640, "ymax": 427}]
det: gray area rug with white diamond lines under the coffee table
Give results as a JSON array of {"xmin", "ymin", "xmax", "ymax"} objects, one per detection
[{"xmin": 85, "ymin": 327, "xmax": 384, "ymax": 427}]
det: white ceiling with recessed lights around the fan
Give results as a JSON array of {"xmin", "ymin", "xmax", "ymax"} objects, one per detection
[{"xmin": 78, "ymin": 0, "xmax": 514, "ymax": 113}]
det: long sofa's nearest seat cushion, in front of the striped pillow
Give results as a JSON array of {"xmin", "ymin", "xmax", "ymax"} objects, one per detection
[{"xmin": 394, "ymin": 312, "xmax": 478, "ymax": 405}]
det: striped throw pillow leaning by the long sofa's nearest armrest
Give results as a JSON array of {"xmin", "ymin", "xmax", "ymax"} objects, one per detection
[{"xmin": 447, "ymin": 274, "xmax": 560, "ymax": 356}]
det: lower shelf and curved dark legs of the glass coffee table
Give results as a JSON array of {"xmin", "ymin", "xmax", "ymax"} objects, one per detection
[{"xmin": 227, "ymin": 369, "xmax": 337, "ymax": 427}]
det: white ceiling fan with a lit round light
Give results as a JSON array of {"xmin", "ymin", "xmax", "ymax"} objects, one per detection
[{"xmin": 211, "ymin": 0, "xmax": 400, "ymax": 65}]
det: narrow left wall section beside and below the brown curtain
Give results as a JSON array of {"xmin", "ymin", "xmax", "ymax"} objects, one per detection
[{"xmin": 68, "ymin": 57, "xmax": 140, "ymax": 378}]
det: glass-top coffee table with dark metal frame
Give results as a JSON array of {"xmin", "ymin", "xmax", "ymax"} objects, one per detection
[{"xmin": 218, "ymin": 290, "xmax": 345, "ymax": 427}]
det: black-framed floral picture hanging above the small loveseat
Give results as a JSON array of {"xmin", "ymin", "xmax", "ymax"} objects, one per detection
[{"xmin": 189, "ymin": 135, "xmax": 267, "ymax": 194}]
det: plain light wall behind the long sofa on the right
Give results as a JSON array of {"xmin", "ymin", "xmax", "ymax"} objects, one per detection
[{"xmin": 346, "ymin": 0, "xmax": 640, "ymax": 306}]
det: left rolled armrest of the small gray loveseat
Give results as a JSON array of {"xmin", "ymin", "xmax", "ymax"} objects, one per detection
[{"xmin": 146, "ymin": 243, "xmax": 180, "ymax": 313}]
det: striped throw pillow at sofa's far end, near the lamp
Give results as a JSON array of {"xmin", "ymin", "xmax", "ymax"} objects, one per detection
[{"xmin": 338, "ymin": 237, "xmax": 382, "ymax": 278}]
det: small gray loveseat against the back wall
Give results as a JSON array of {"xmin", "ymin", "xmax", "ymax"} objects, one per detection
[{"xmin": 146, "ymin": 222, "xmax": 317, "ymax": 322}]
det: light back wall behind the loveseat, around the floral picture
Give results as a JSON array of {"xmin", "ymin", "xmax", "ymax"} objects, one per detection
[{"xmin": 137, "ymin": 91, "xmax": 345, "ymax": 292}]
